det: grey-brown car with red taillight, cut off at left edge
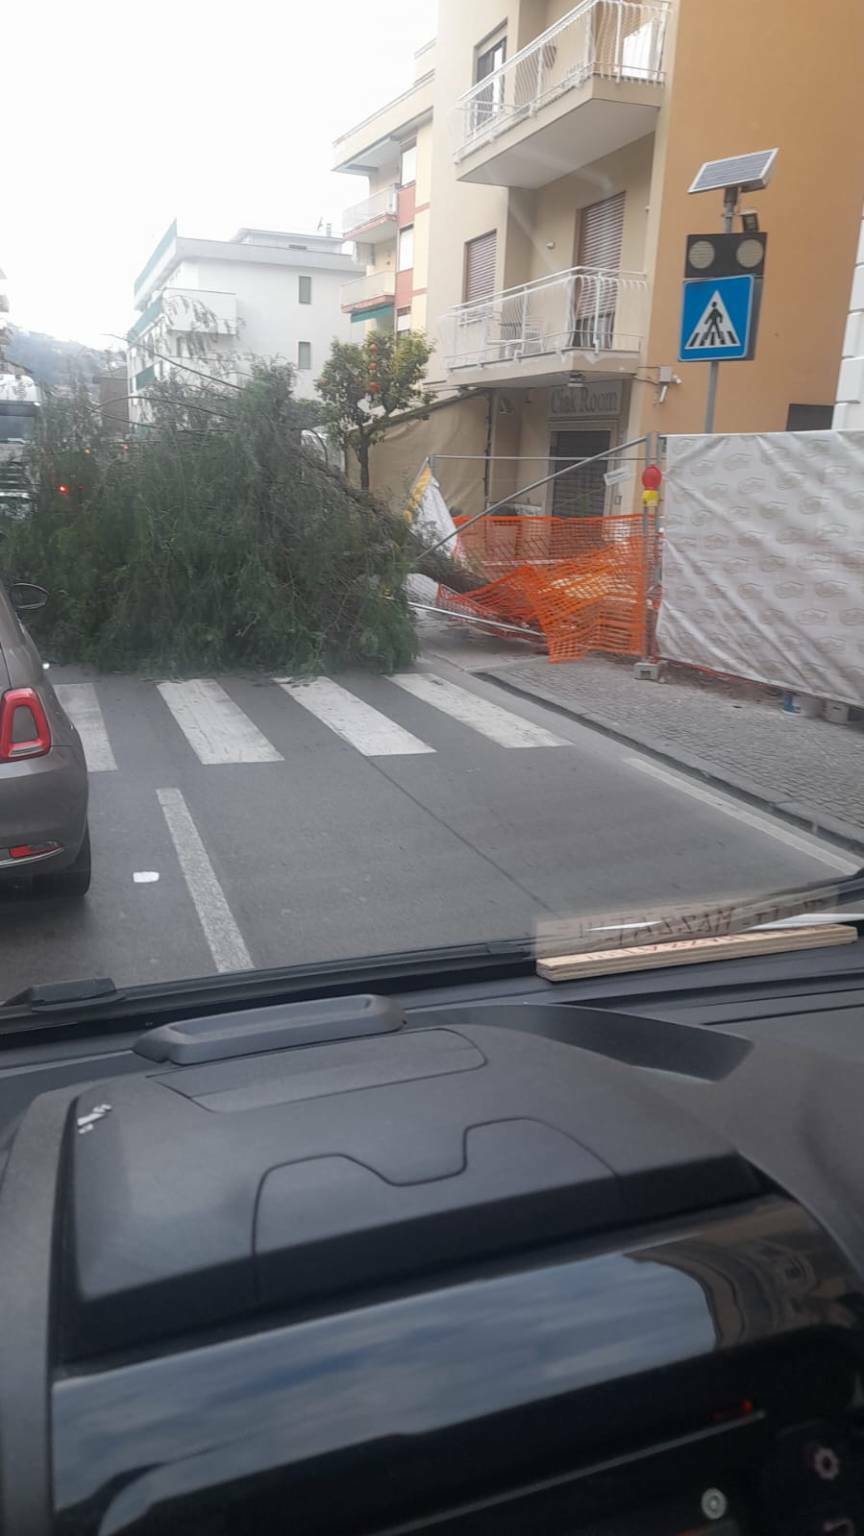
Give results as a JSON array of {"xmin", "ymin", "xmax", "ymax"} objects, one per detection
[{"xmin": 0, "ymin": 582, "xmax": 91, "ymax": 897}]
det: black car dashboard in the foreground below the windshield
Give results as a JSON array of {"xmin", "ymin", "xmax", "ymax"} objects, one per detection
[{"xmin": 0, "ymin": 942, "xmax": 864, "ymax": 1536}]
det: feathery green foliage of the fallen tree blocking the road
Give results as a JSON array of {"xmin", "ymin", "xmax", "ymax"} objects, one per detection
[{"xmin": 0, "ymin": 366, "xmax": 417, "ymax": 673}]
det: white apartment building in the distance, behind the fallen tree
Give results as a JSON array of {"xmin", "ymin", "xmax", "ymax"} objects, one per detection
[{"xmin": 128, "ymin": 221, "xmax": 363, "ymax": 421}]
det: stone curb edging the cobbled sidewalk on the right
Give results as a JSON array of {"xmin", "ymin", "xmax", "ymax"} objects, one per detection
[{"xmin": 474, "ymin": 671, "xmax": 864, "ymax": 856}]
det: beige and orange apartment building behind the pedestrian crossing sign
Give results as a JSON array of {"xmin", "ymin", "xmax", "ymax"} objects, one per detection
[{"xmin": 328, "ymin": 0, "xmax": 864, "ymax": 515}]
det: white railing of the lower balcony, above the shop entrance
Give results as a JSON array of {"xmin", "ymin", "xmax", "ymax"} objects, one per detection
[{"xmin": 438, "ymin": 267, "xmax": 647, "ymax": 369}]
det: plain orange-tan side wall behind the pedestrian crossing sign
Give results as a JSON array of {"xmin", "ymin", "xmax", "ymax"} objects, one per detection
[{"xmin": 635, "ymin": 0, "xmax": 864, "ymax": 433}]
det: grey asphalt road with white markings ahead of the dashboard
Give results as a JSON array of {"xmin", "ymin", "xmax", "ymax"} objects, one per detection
[{"xmin": 0, "ymin": 647, "xmax": 858, "ymax": 997}]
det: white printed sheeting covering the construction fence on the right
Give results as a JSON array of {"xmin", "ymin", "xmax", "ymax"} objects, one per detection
[{"xmin": 658, "ymin": 432, "xmax": 864, "ymax": 705}]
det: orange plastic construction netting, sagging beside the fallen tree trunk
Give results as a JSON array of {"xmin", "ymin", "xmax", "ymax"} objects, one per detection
[{"xmin": 438, "ymin": 515, "xmax": 647, "ymax": 662}]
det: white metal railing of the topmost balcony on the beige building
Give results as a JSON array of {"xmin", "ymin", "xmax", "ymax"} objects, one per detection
[{"xmin": 452, "ymin": 0, "xmax": 669, "ymax": 158}]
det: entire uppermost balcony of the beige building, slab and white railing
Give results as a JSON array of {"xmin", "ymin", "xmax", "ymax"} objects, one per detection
[{"xmin": 452, "ymin": 0, "xmax": 669, "ymax": 187}]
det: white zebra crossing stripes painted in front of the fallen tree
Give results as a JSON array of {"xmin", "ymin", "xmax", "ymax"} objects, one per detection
[{"xmin": 57, "ymin": 671, "xmax": 566, "ymax": 774}]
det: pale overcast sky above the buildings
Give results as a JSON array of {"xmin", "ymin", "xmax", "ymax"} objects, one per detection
[{"xmin": 0, "ymin": 0, "xmax": 437, "ymax": 347}]
